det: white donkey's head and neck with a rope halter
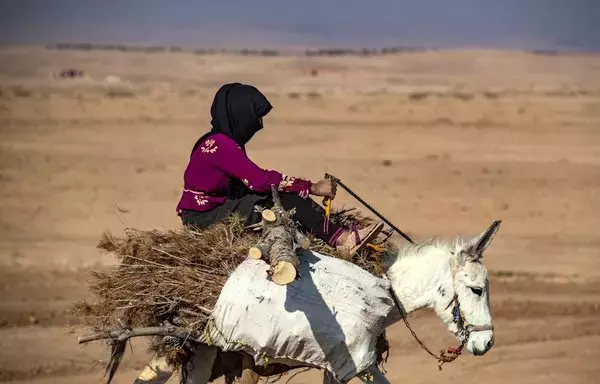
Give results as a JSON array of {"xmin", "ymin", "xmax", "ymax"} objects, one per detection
[{"xmin": 387, "ymin": 221, "xmax": 501, "ymax": 355}]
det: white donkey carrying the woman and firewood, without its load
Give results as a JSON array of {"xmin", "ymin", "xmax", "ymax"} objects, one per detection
[{"xmin": 135, "ymin": 221, "xmax": 501, "ymax": 384}]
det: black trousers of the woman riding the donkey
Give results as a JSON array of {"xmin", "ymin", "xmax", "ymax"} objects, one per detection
[{"xmin": 181, "ymin": 193, "xmax": 340, "ymax": 242}]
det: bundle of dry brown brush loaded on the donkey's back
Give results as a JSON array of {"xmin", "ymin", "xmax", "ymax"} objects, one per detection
[{"xmin": 71, "ymin": 204, "xmax": 394, "ymax": 376}]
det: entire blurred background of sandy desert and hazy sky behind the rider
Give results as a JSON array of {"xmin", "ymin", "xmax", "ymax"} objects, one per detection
[{"xmin": 0, "ymin": 0, "xmax": 600, "ymax": 384}]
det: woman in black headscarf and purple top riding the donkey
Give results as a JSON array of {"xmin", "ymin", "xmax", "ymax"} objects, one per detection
[{"xmin": 177, "ymin": 83, "xmax": 383, "ymax": 255}]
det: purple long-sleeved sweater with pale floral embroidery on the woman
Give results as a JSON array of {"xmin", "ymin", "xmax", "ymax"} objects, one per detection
[{"xmin": 177, "ymin": 133, "xmax": 312, "ymax": 213}]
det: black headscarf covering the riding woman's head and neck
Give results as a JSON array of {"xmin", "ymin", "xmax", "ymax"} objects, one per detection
[{"xmin": 192, "ymin": 83, "xmax": 273, "ymax": 153}]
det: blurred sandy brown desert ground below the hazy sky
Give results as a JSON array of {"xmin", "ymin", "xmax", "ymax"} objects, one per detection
[{"xmin": 0, "ymin": 47, "xmax": 600, "ymax": 384}]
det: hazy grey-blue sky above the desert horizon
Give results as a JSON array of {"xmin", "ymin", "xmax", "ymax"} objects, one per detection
[{"xmin": 0, "ymin": 0, "xmax": 600, "ymax": 50}]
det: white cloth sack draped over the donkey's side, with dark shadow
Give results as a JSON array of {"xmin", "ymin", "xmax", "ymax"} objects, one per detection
[{"xmin": 206, "ymin": 251, "xmax": 394, "ymax": 382}]
